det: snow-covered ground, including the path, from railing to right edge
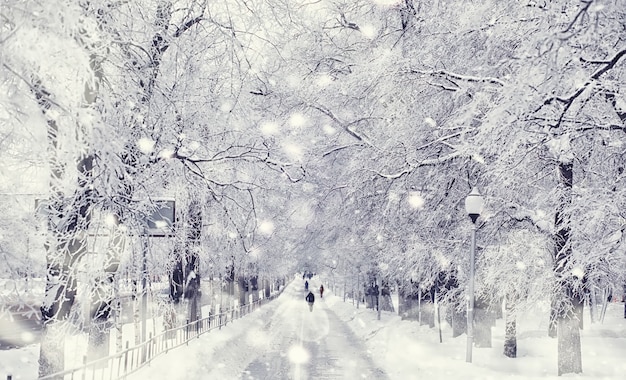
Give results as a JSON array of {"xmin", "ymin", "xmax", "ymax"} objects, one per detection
[{"xmin": 0, "ymin": 279, "xmax": 626, "ymax": 380}]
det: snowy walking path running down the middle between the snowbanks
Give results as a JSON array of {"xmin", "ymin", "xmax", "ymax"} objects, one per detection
[{"xmin": 239, "ymin": 287, "xmax": 385, "ymax": 379}]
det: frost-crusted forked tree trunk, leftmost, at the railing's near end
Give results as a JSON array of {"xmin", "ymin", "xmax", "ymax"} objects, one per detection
[{"xmin": 33, "ymin": 82, "xmax": 93, "ymax": 377}]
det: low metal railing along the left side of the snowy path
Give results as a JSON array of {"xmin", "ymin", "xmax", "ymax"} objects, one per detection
[{"xmin": 36, "ymin": 286, "xmax": 285, "ymax": 380}]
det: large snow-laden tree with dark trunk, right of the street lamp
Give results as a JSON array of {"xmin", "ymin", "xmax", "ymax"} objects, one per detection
[{"xmin": 464, "ymin": 2, "xmax": 624, "ymax": 374}]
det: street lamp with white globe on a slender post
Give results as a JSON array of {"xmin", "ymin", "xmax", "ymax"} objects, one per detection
[{"xmin": 465, "ymin": 187, "xmax": 484, "ymax": 363}]
